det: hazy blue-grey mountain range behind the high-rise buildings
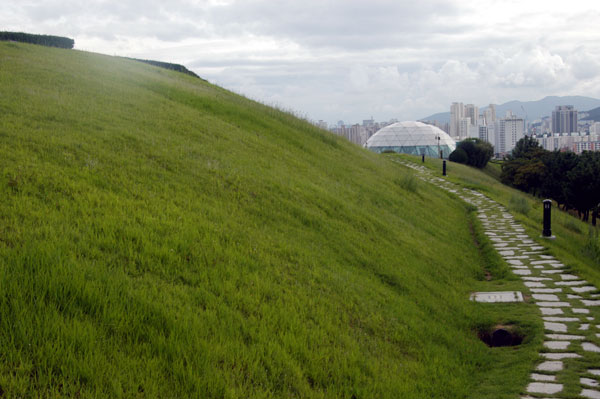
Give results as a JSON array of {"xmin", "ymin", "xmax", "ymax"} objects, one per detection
[{"xmin": 421, "ymin": 96, "xmax": 600, "ymax": 123}]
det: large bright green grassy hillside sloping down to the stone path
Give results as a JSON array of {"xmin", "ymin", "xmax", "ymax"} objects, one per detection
[{"xmin": 0, "ymin": 43, "xmax": 541, "ymax": 398}]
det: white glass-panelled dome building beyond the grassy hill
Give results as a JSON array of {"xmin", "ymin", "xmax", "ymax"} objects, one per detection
[{"xmin": 365, "ymin": 121, "xmax": 456, "ymax": 158}]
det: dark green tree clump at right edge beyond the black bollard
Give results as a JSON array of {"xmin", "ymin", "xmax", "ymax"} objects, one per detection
[{"xmin": 500, "ymin": 136, "xmax": 600, "ymax": 226}]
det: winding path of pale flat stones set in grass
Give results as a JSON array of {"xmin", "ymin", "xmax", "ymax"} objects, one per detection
[{"xmin": 396, "ymin": 160, "xmax": 600, "ymax": 399}]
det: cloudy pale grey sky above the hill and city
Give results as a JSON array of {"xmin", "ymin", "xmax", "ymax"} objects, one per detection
[{"xmin": 0, "ymin": 0, "xmax": 600, "ymax": 124}]
